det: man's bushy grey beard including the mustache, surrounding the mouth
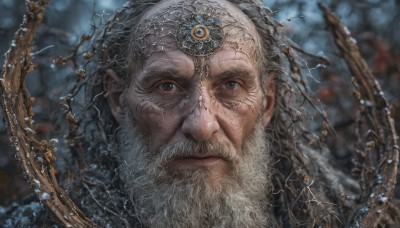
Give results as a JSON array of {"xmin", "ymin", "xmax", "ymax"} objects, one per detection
[{"xmin": 118, "ymin": 120, "xmax": 271, "ymax": 227}]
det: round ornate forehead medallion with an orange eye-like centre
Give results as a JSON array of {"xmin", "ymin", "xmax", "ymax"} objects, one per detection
[{"xmin": 176, "ymin": 14, "xmax": 224, "ymax": 56}]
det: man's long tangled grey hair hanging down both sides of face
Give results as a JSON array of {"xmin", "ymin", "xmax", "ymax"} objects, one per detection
[{"xmin": 75, "ymin": 0, "xmax": 357, "ymax": 227}]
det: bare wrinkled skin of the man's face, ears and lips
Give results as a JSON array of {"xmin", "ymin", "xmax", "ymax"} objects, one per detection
[{"xmin": 106, "ymin": 0, "xmax": 275, "ymax": 183}]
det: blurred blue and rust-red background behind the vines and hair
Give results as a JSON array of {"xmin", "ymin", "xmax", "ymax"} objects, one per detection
[{"xmin": 0, "ymin": 0, "xmax": 400, "ymax": 209}]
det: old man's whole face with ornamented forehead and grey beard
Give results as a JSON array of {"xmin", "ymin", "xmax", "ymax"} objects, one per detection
[{"xmin": 109, "ymin": 0, "xmax": 274, "ymax": 227}]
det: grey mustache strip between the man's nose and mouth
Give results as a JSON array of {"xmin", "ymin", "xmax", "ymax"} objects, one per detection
[{"xmin": 158, "ymin": 139, "xmax": 239, "ymax": 163}]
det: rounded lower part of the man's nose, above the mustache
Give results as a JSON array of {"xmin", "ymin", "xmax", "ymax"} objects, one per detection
[{"xmin": 182, "ymin": 99, "xmax": 220, "ymax": 141}]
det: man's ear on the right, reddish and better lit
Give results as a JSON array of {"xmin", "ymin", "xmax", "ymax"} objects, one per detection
[{"xmin": 262, "ymin": 75, "xmax": 276, "ymax": 127}]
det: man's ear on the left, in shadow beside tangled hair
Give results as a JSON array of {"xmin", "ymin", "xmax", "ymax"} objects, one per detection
[{"xmin": 103, "ymin": 69, "xmax": 125, "ymax": 123}]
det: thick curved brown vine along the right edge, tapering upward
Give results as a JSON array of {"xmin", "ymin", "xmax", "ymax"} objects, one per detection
[{"xmin": 319, "ymin": 4, "xmax": 399, "ymax": 227}]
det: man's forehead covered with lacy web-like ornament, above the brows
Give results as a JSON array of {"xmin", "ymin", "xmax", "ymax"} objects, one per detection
[{"xmin": 133, "ymin": 0, "xmax": 260, "ymax": 58}]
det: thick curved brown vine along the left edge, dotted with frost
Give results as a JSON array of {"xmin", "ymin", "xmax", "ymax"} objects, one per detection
[{"xmin": 0, "ymin": 0, "xmax": 96, "ymax": 227}]
